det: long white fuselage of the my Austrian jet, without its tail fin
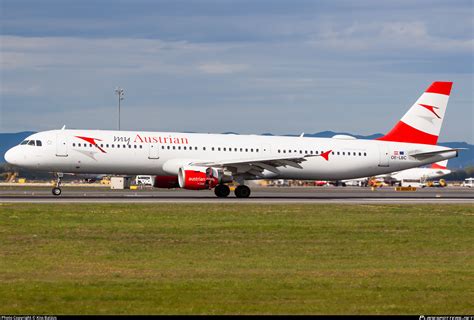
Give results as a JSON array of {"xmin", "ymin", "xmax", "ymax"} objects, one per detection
[{"xmin": 5, "ymin": 130, "xmax": 457, "ymax": 180}]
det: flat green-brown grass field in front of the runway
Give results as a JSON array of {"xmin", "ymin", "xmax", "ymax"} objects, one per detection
[{"xmin": 0, "ymin": 204, "xmax": 474, "ymax": 314}]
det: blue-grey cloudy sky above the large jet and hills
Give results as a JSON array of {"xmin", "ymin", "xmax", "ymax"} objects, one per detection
[{"xmin": 0, "ymin": 0, "xmax": 474, "ymax": 143}]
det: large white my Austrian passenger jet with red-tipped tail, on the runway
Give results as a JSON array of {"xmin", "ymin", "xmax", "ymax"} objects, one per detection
[{"xmin": 5, "ymin": 81, "xmax": 460, "ymax": 198}]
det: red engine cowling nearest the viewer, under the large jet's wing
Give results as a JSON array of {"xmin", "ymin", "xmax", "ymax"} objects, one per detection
[{"xmin": 178, "ymin": 166, "xmax": 219, "ymax": 190}]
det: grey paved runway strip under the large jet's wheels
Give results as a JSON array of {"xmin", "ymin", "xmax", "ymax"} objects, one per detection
[{"xmin": 0, "ymin": 186, "xmax": 474, "ymax": 204}]
